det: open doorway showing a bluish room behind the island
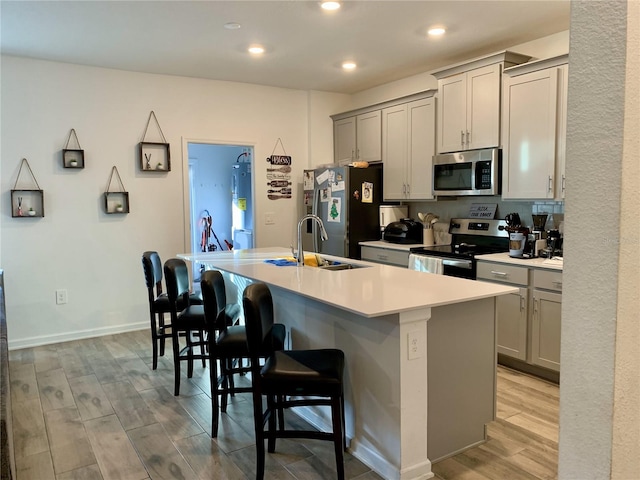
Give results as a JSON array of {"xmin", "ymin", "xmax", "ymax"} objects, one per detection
[{"xmin": 187, "ymin": 142, "xmax": 254, "ymax": 281}]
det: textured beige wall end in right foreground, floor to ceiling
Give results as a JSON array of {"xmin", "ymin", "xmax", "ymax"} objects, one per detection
[{"xmin": 558, "ymin": 0, "xmax": 640, "ymax": 480}]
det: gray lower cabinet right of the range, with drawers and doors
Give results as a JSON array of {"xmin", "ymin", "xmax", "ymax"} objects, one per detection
[{"xmin": 477, "ymin": 260, "xmax": 562, "ymax": 372}]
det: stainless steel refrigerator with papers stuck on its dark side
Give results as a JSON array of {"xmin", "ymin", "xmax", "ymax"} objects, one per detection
[{"xmin": 303, "ymin": 163, "xmax": 382, "ymax": 259}]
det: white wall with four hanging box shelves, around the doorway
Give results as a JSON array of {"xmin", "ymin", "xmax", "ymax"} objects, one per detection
[{"xmin": 0, "ymin": 57, "xmax": 320, "ymax": 348}]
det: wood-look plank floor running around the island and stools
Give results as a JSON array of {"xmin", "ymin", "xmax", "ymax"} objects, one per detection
[{"xmin": 9, "ymin": 331, "xmax": 559, "ymax": 480}]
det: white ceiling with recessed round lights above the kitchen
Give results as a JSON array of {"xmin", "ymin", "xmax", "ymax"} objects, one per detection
[{"xmin": 0, "ymin": 0, "xmax": 569, "ymax": 93}]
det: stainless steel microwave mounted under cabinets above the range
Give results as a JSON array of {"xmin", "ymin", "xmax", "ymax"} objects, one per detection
[{"xmin": 433, "ymin": 148, "xmax": 502, "ymax": 197}]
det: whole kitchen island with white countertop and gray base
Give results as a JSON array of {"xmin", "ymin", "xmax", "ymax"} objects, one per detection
[{"xmin": 179, "ymin": 248, "xmax": 515, "ymax": 480}]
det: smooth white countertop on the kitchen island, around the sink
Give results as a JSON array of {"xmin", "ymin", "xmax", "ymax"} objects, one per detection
[{"xmin": 178, "ymin": 247, "xmax": 517, "ymax": 317}]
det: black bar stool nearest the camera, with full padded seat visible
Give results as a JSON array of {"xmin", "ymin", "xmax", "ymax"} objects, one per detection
[{"xmin": 242, "ymin": 283, "xmax": 345, "ymax": 480}]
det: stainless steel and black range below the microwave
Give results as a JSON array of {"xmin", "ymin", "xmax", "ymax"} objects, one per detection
[{"xmin": 411, "ymin": 218, "xmax": 509, "ymax": 280}]
